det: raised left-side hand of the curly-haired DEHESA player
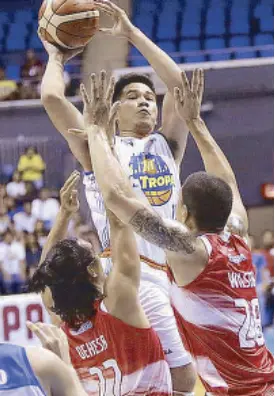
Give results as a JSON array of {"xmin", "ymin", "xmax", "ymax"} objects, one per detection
[{"xmin": 60, "ymin": 171, "xmax": 80, "ymax": 214}]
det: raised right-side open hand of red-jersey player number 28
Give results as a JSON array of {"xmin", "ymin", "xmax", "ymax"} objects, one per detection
[{"xmin": 174, "ymin": 69, "xmax": 204, "ymax": 122}]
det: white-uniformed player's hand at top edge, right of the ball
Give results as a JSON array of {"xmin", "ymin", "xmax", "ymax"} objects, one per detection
[{"xmin": 95, "ymin": 0, "xmax": 135, "ymax": 39}]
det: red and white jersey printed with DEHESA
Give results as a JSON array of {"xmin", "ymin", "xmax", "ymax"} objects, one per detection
[{"xmin": 63, "ymin": 303, "xmax": 172, "ymax": 396}]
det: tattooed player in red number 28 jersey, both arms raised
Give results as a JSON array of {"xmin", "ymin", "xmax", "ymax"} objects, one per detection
[{"xmin": 83, "ymin": 70, "xmax": 273, "ymax": 396}]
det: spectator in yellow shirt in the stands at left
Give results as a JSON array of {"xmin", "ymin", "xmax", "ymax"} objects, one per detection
[{"xmin": 17, "ymin": 146, "xmax": 46, "ymax": 189}]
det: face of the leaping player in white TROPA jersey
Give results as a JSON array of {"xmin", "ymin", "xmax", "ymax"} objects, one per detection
[{"xmin": 118, "ymin": 83, "xmax": 158, "ymax": 137}]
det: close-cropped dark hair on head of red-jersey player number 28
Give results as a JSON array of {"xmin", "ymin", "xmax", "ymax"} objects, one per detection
[{"xmin": 182, "ymin": 172, "xmax": 233, "ymax": 233}]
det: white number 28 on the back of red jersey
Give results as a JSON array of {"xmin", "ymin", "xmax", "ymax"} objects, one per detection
[{"xmin": 235, "ymin": 298, "xmax": 264, "ymax": 348}]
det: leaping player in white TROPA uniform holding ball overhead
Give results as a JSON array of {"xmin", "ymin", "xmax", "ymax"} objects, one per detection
[{"xmin": 41, "ymin": 2, "xmax": 195, "ymax": 392}]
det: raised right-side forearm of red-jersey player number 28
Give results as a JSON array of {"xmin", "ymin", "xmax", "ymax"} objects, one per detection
[{"xmin": 187, "ymin": 118, "xmax": 236, "ymax": 184}]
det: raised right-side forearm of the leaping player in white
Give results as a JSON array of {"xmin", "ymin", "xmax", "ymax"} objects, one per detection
[{"xmin": 129, "ymin": 27, "xmax": 182, "ymax": 93}]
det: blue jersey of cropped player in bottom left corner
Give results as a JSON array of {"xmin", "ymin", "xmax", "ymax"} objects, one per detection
[{"xmin": 0, "ymin": 343, "xmax": 46, "ymax": 396}]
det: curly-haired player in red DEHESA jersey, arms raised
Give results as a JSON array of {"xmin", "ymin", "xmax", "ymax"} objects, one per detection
[{"xmin": 30, "ymin": 172, "xmax": 172, "ymax": 396}]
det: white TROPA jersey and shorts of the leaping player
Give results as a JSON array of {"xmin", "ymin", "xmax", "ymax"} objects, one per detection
[{"xmin": 84, "ymin": 133, "xmax": 191, "ymax": 368}]
